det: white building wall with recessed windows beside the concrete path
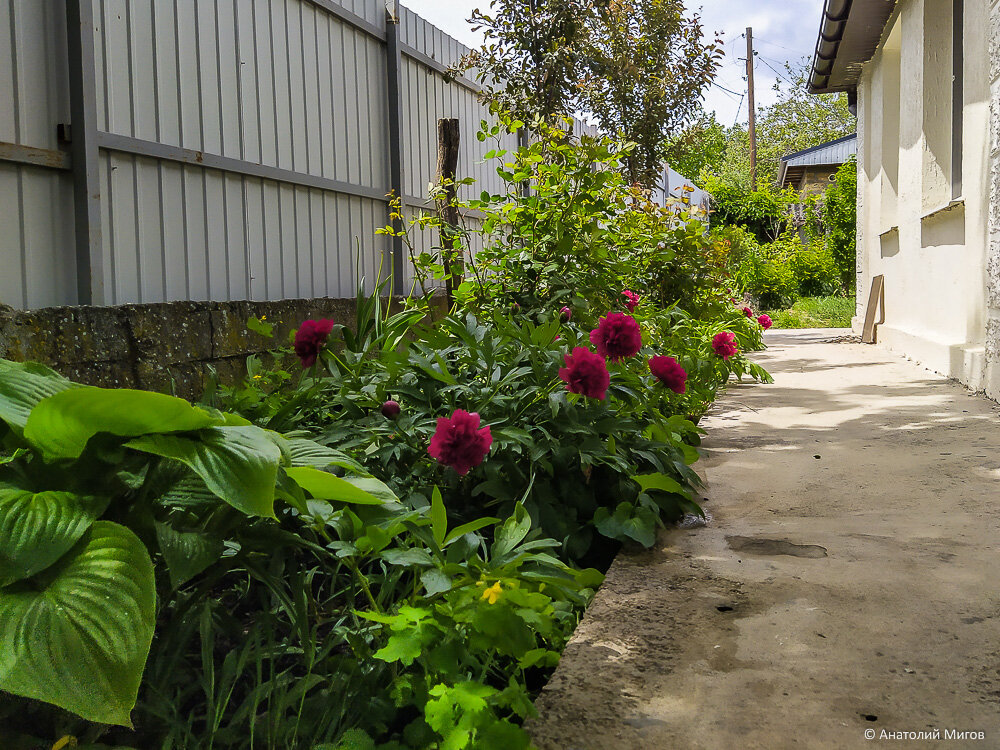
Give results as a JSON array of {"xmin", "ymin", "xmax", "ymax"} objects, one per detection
[{"xmin": 855, "ymin": 0, "xmax": 1000, "ymax": 396}]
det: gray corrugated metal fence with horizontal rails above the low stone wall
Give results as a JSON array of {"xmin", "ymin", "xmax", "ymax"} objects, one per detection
[{"xmin": 0, "ymin": 0, "xmax": 532, "ymax": 308}]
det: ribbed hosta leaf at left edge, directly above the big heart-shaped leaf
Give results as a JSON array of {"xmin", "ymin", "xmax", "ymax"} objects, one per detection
[{"xmin": 0, "ymin": 489, "xmax": 108, "ymax": 587}]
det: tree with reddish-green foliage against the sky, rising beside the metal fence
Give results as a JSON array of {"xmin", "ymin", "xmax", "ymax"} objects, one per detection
[{"xmin": 461, "ymin": 0, "xmax": 722, "ymax": 182}]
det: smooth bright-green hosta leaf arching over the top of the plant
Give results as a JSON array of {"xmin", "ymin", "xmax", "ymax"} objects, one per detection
[{"xmin": 24, "ymin": 387, "xmax": 223, "ymax": 458}]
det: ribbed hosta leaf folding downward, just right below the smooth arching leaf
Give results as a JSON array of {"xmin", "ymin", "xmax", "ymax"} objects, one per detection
[{"xmin": 126, "ymin": 427, "xmax": 281, "ymax": 518}]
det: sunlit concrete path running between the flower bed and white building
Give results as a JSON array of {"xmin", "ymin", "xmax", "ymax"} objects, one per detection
[{"xmin": 529, "ymin": 331, "xmax": 1000, "ymax": 750}]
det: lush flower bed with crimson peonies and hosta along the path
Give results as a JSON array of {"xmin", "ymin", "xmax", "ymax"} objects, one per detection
[{"xmin": 0, "ymin": 120, "xmax": 767, "ymax": 748}]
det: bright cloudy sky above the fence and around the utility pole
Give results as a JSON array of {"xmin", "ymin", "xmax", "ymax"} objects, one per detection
[{"xmin": 402, "ymin": 0, "xmax": 823, "ymax": 125}]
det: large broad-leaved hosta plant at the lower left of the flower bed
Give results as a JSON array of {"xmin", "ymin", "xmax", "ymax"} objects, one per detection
[{"xmin": 0, "ymin": 360, "xmax": 392, "ymax": 726}]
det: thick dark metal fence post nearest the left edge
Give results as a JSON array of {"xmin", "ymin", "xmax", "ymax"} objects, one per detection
[{"xmin": 66, "ymin": 0, "xmax": 105, "ymax": 305}]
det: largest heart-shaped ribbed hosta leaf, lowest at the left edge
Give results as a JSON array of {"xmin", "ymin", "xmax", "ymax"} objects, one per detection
[{"xmin": 0, "ymin": 521, "xmax": 156, "ymax": 726}]
